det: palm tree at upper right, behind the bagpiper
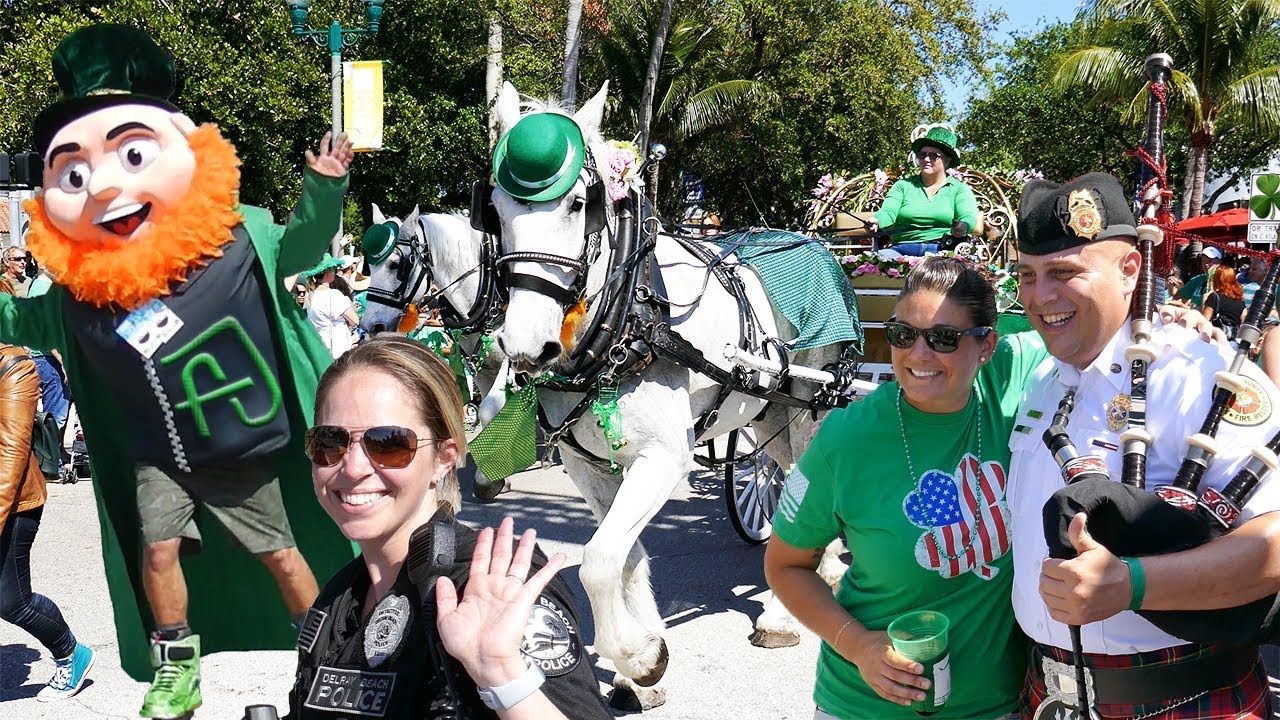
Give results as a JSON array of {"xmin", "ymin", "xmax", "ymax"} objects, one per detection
[{"xmin": 1055, "ymin": 0, "xmax": 1280, "ymax": 217}]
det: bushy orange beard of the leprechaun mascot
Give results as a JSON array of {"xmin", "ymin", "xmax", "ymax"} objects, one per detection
[{"xmin": 23, "ymin": 124, "xmax": 243, "ymax": 310}]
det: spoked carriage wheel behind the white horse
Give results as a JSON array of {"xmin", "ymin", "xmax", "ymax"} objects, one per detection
[{"xmin": 724, "ymin": 428, "xmax": 787, "ymax": 544}]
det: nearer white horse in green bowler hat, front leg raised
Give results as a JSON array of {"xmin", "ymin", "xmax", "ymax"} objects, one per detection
[{"xmin": 493, "ymin": 83, "xmax": 842, "ymax": 707}]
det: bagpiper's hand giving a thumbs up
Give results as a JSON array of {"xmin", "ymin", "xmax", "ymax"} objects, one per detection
[{"xmin": 1039, "ymin": 512, "xmax": 1130, "ymax": 625}]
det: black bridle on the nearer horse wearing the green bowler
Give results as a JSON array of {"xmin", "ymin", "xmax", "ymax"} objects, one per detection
[{"xmin": 488, "ymin": 151, "xmax": 607, "ymax": 310}]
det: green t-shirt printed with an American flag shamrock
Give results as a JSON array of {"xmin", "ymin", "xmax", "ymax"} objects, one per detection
[{"xmin": 773, "ymin": 333, "xmax": 1047, "ymax": 720}]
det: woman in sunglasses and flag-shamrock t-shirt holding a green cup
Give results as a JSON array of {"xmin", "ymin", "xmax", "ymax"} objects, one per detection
[{"xmin": 764, "ymin": 256, "xmax": 1046, "ymax": 720}]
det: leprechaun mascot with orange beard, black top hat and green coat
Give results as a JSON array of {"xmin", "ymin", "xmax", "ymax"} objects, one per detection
[{"xmin": 0, "ymin": 24, "xmax": 353, "ymax": 717}]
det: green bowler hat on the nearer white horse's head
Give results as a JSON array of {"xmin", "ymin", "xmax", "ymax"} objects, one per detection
[{"xmin": 493, "ymin": 113, "xmax": 586, "ymax": 202}]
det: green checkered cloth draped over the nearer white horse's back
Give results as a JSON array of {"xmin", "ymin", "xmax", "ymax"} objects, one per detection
[{"xmin": 708, "ymin": 231, "xmax": 863, "ymax": 355}]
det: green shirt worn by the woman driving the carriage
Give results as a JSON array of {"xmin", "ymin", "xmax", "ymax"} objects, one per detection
[{"xmin": 876, "ymin": 176, "xmax": 978, "ymax": 245}]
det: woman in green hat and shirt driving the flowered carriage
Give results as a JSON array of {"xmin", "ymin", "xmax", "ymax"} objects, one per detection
[{"xmin": 867, "ymin": 126, "xmax": 978, "ymax": 255}]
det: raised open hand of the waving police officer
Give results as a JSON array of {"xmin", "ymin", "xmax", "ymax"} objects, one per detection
[{"xmin": 435, "ymin": 518, "xmax": 564, "ymax": 688}]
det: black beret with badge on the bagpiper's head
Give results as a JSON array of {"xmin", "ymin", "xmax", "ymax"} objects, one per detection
[{"xmin": 1018, "ymin": 173, "xmax": 1138, "ymax": 255}]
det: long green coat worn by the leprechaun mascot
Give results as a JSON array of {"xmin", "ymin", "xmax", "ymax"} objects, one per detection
[{"xmin": 0, "ymin": 172, "xmax": 356, "ymax": 680}]
